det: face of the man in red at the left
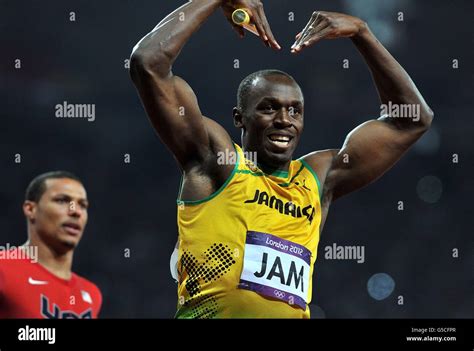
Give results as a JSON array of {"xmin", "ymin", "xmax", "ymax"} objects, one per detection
[{"xmin": 23, "ymin": 178, "xmax": 89, "ymax": 252}]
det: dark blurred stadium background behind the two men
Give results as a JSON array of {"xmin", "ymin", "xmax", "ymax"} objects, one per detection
[{"xmin": 0, "ymin": 0, "xmax": 474, "ymax": 318}]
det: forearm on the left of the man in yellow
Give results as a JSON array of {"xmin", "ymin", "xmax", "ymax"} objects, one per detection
[{"xmin": 132, "ymin": 0, "xmax": 224, "ymax": 76}]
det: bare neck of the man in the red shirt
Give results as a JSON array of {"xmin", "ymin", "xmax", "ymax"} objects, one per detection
[{"xmin": 23, "ymin": 235, "xmax": 74, "ymax": 280}]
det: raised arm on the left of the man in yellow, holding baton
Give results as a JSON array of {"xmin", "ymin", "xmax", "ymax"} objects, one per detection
[{"xmin": 130, "ymin": 0, "xmax": 276, "ymax": 168}]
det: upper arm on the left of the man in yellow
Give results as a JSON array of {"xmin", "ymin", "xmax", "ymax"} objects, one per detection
[{"xmin": 133, "ymin": 69, "xmax": 209, "ymax": 166}]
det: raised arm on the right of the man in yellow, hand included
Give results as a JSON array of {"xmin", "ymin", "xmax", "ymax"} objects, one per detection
[{"xmin": 292, "ymin": 11, "xmax": 433, "ymax": 200}]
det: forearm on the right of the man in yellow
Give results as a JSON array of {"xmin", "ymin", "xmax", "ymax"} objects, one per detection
[{"xmin": 352, "ymin": 24, "xmax": 433, "ymax": 127}]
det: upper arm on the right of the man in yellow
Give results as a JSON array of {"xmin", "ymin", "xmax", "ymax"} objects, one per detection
[{"xmin": 327, "ymin": 118, "xmax": 424, "ymax": 199}]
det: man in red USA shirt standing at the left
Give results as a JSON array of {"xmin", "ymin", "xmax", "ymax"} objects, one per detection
[{"xmin": 0, "ymin": 171, "xmax": 102, "ymax": 318}]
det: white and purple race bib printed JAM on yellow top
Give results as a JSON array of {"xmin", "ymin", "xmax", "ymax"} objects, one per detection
[{"xmin": 239, "ymin": 231, "xmax": 311, "ymax": 310}]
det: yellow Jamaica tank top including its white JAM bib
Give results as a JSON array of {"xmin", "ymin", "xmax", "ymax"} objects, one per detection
[{"xmin": 176, "ymin": 143, "xmax": 321, "ymax": 318}]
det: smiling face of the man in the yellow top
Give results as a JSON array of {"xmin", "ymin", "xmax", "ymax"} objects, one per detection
[{"xmin": 236, "ymin": 75, "xmax": 304, "ymax": 168}]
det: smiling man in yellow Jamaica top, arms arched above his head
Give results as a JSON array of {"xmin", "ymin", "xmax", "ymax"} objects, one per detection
[{"xmin": 130, "ymin": 0, "xmax": 433, "ymax": 318}]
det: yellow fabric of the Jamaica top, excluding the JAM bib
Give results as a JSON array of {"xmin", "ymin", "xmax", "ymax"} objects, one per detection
[{"xmin": 176, "ymin": 143, "xmax": 321, "ymax": 318}]
